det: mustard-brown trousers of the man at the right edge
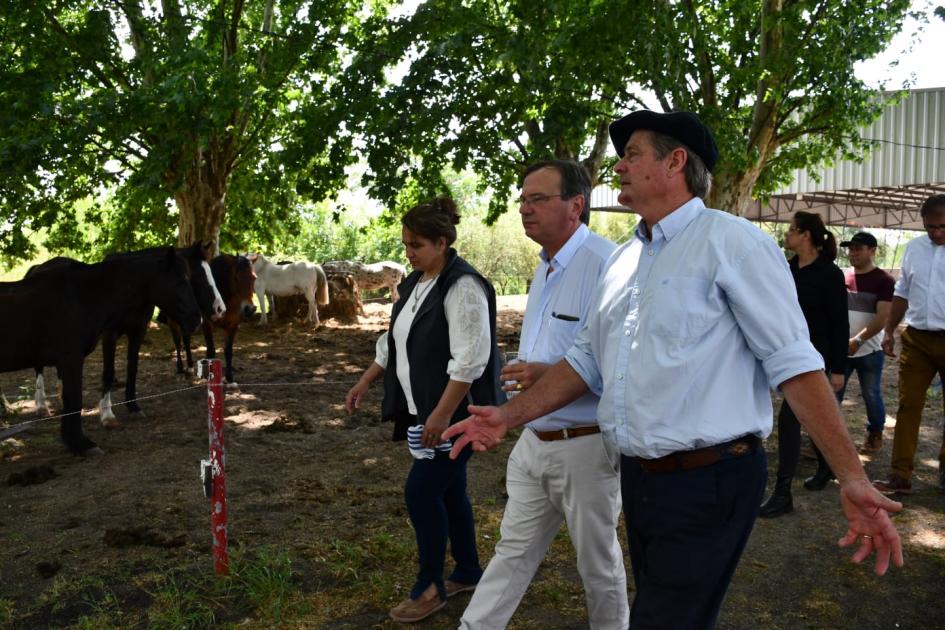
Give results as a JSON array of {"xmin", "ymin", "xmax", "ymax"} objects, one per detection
[{"xmin": 892, "ymin": 327, "xmax": 945, "ymax": 479}]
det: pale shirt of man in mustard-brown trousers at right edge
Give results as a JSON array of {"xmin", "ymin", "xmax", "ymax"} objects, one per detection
[{"xmin": 894, "ymin": 234, "xmax": 945, "ymax": 330}]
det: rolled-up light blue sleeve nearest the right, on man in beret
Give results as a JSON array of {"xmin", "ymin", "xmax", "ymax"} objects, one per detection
[{"xmin": 720, "ymin": 237, "xmax": 824, "ymax": 389}]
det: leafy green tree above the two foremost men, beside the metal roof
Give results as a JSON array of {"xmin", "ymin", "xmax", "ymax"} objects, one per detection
[{"xmin": 350, "ymin": 0, "xmax": 909, "ymax": 218}]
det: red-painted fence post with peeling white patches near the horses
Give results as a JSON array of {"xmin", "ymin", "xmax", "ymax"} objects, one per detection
[{"xmin": 207, "ymin": 359, "xmax": 230, "ymax": 575}]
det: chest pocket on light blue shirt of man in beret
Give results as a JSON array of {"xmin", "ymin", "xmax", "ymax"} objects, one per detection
[{"xmin": 645, "ymin": 276, "xmax": 711, "ymax": 344}]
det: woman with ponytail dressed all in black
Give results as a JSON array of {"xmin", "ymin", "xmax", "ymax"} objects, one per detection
[{"xmin": 759, "ymin": 212, "xmax": 850, "ymax": 518}]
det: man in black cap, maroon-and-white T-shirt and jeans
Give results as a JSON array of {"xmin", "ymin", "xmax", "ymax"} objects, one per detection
[{"xmin": 837, "ymin": 232, "xmax": 896, "ymax": 455}]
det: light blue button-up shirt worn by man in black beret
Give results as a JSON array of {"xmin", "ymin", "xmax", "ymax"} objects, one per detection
[{"xmin": 565, "ymin": 198, "xmax": 824, "ymax": 458}]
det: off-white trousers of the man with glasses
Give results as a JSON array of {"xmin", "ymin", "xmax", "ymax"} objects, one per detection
[{"xmin": 460, "ymin": 428, "xmax": 630, "ymax": 630}]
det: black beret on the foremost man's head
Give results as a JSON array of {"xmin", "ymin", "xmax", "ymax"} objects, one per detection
[{"xmin": 610, "ymin": 109, "xmax": 719, "ymax": 173}]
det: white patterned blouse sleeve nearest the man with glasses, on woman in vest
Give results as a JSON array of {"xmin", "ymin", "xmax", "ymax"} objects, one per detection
[{"xmin": 444, "ymin": 275, "xmax": 492, "ymax": 383}]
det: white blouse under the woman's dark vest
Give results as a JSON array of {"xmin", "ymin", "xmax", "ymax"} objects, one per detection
[{"xmin": 374, "ymin": 274, "xmax": 492, "ymax": 420}]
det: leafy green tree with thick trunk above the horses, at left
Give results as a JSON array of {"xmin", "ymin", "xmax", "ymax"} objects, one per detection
[{"xmin": 0, "ymin": 0, "xmax": 361, "ymax": 257}]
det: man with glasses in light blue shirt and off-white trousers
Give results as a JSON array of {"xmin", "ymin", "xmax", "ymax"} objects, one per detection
[{"xmin": 458, "ymin": 160, "xmax": 630, "ymax": 630}]
